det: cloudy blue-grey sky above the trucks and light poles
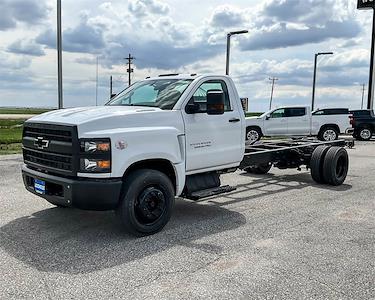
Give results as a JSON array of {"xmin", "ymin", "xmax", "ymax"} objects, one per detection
[{"xmin": 0, "ymin": 0, "xmax": 371, "ymax": 111}]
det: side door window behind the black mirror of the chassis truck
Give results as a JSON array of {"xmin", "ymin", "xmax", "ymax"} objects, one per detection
[{"xmin": 189, "ymin": 80, "xmax": 231, "ymax": 113}]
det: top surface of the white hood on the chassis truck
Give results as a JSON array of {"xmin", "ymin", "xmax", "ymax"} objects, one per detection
[{"xmin": 28, "ymin": 106, "xmax": 161, "ymax": 125}]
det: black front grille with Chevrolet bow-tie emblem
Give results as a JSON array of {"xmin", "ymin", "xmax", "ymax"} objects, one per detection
[{"xmin": 22, "ymin": 122, "xmax": 79, "ymax": 176}]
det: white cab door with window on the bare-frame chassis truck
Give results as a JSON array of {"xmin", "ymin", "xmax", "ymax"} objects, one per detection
[{"xmin": 182, "ymin": 80, "xmax": 245, "ymax": 173}]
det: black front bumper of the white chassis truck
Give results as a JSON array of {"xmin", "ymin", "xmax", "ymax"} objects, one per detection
[{"xmin": 22, "ymin": 165, "xmax": 122, "ymax": 210}]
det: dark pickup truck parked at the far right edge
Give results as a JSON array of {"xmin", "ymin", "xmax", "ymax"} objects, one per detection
[{"xmin": 350, "ymin": 110, "xmax": 375, "ymax": 141}]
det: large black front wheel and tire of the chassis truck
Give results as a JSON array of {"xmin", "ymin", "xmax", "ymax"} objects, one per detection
[{"xmin": 116, "ymin": 169, "xmax": 175, "ymax": 237}]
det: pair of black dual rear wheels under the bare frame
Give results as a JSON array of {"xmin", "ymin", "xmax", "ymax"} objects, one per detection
[{"xmin": 310, "ymin": 146, "xmax": 349, "ymax": 186}]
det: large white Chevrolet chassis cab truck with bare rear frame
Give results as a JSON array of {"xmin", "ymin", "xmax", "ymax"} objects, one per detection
[{"xmin": 22, "ymin": 75, "xmax": 356, "ymax": 236}]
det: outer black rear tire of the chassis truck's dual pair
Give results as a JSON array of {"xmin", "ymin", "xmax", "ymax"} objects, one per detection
[{"xmin": 323, "ymin": 147, "xmax": 349, "ymax": 186}]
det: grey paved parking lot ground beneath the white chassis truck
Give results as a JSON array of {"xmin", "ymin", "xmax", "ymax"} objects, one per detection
[{"xmin": 0, "ymin": 142, "xmax": 375, "ymax": 299}]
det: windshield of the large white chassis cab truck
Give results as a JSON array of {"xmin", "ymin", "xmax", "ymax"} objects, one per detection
[{"xmin": 107, "ymin": 79, "xmax": 193, "ymax": 110}]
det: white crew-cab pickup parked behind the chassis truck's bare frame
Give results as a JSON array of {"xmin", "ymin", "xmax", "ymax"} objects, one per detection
[{"xmin": 246, "ymin": 106, "xmax": 354, "ymax": 142}]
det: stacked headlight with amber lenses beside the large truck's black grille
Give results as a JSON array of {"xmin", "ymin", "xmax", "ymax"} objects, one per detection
[{"xmin": 80, "ymin": 139, "xmax": 111, "ymax": 173}]
